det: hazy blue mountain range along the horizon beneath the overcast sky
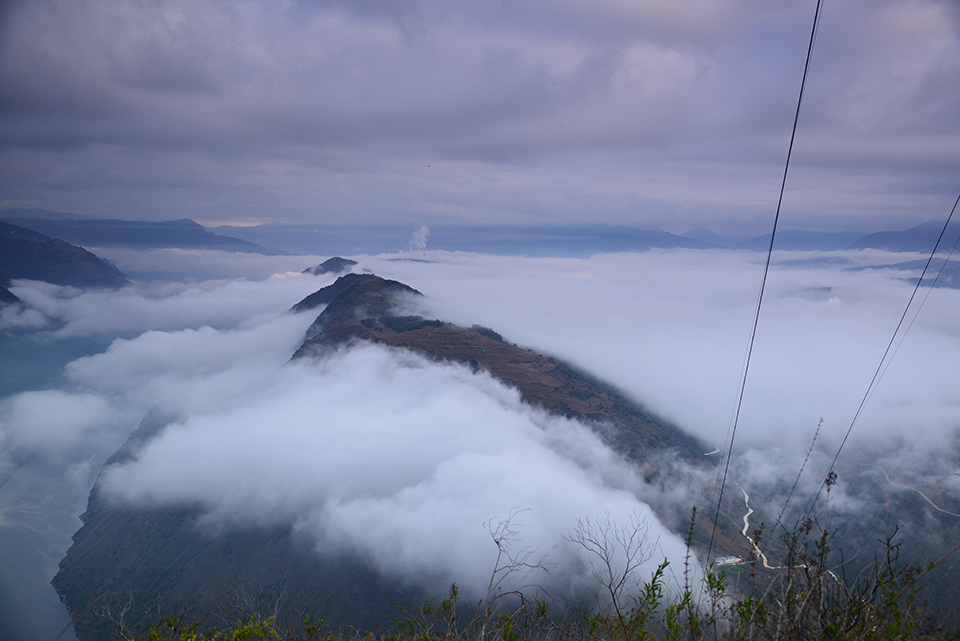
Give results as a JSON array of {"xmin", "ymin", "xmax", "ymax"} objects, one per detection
[{"xmin": 0, "ymin": 208, "xmax": 956, "ymax": 256}]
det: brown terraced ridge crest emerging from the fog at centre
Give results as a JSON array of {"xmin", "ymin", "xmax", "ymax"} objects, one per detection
[{"xmin": 293, "ymin": 274, "xmax": 706, "ymax": 460}]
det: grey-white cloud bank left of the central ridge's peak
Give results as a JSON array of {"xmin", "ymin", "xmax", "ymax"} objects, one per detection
[{"xmin": 0, "ymin": 270, "xmax": 322, "ymax": 470}]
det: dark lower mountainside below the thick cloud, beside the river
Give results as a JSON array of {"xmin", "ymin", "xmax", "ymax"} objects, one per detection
[{"xmin": 52, "ymin": 412, "xmax": 412, "ymax": 641}]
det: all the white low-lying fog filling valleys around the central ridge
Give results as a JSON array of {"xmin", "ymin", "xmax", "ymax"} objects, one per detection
[{"xmin": 0, "ymin": 250, "xmax": 960, "ymax": 638}]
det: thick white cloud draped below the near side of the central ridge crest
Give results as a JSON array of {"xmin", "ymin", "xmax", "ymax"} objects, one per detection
[{"xmin": 102, "ymin": 346, "xmax": 684, "ymax": 597}]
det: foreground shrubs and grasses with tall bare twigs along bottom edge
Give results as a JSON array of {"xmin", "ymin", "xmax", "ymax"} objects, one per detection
[{"xmin": 109, "ymin": 510, "xmax": 960, "ymax": 641}]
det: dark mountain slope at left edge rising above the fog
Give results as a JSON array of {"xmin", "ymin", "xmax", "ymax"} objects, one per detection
[{"xmin": 0, "ymin": 222, "xmax": 127, "ymax": 287}]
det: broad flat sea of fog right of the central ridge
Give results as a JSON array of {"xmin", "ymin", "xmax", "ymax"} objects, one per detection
[{"xmin": 356, "ymin": 251, "xmax": 960, "ymax": 451}]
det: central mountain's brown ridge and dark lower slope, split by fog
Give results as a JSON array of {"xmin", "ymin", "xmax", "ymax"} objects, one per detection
[{"xmin": 53, "ymin": 274, "xmax": 716, "ymax": 641}]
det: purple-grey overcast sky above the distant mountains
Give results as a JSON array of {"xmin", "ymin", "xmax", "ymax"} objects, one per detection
[{"xmin": 0, "ymin": 0, "xmax": 960, "ymax": 234}]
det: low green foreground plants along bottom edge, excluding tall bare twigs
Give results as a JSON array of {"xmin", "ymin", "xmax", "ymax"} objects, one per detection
[{"xmin": 119, "ymin": 562, "xmax": 960, "ymax": 641}]
